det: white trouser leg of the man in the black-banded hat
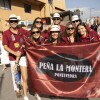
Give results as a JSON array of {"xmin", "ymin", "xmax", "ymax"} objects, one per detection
[{"xmin": 10, "ymin": 61, "xmax": 19, "ymax": 91}]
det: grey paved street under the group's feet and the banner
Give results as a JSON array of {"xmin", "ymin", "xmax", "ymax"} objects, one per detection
[{"xmin": 0, "ymin": 66, "xmax": 100, "ymax": 100}]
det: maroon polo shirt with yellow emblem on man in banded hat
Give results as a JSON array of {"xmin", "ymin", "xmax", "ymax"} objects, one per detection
[{"xmin": 3, "ymin": 28, "xmax": 30, "ymax": 61}]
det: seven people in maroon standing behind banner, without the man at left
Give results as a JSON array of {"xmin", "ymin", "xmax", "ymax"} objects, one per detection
[{"xmin": 30, "ymin": 13, "xmax": 100, "ymax": 44}]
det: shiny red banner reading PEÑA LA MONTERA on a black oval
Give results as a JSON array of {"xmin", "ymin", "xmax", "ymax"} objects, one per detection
[{"xmin": 25, "ymin": 38, "xmax": 100, "ymax": 98}]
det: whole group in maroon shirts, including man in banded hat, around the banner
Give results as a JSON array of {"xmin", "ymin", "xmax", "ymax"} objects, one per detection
[{"xmin": 2, "ymin": 13, "xmax": 100, "ymax": 100}]
